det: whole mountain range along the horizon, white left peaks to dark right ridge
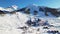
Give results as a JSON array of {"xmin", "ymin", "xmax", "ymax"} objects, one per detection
[{"xmin": 0, "ymin": 5, "xmax": 60, "ymax": 17}]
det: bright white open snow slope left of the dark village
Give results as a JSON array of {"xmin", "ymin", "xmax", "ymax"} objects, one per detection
[{"xmin": 0, "ymin": 12, "xmax": 28, "ymax": 34}]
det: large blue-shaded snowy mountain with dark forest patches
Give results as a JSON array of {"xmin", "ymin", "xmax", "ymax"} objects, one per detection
[{"xmin": 17, "ymin": 4, "xmax": 60, "ymax": 17}]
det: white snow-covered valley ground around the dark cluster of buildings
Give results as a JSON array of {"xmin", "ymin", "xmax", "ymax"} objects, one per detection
[{"xmin": 0, "ymin": 12, "xmax": 60, "ymax": 34}]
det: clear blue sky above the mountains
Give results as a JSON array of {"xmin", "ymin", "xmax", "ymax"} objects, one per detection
[{"xmin": 0, "ymin": 0, "xmax": 60, "ymax": 8}]
